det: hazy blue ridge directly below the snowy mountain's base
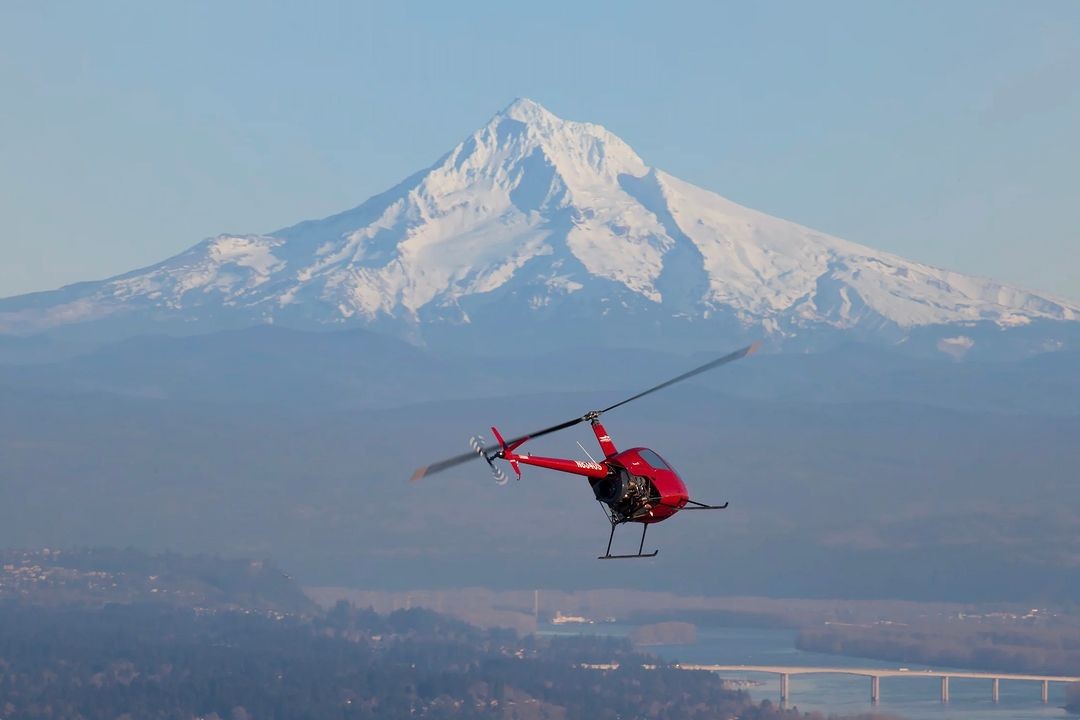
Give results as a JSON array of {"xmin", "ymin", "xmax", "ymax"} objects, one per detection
[{"xmin": 0, "ymin": 326, "xmax": 1080, "ymax": 415}]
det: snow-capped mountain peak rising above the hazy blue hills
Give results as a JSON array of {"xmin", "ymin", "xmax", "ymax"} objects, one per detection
[{"xmin": 0, "ymin": 99, "xmax": 1080, "ymax": 352}]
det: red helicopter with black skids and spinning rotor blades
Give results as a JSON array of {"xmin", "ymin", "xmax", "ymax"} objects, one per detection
[{"xmin": 411, "ymin": 342, "xmax": 761, "ymax": 560}]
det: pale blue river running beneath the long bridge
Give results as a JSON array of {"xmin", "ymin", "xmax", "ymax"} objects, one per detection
[{"xmin": 540, "ymin": 624, "xmax": 1075, "ymax": 720}]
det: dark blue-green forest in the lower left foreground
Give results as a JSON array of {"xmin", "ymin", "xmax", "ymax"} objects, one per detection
[{"xmin": 0, "ymin": 601, "xmax": 894, "ymax": 720}]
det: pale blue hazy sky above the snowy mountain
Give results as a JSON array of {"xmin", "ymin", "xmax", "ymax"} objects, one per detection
[{"xmin": 0, "ymin": 0, "xmax": 1080, "ymax": 300}]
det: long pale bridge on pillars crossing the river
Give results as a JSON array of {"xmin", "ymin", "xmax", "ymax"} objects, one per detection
[{"xmin": 676, "ymin": 663, "xmax": 1080, "ymax": 703}]
